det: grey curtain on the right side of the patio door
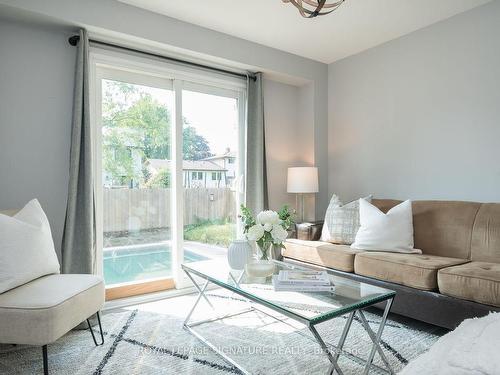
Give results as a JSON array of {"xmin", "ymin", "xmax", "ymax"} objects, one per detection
[{"xmin": 246, "ymin": 73, "xmax": 269, "ymax": 214}]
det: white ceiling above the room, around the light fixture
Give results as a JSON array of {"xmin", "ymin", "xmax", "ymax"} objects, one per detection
[{"xmin": 119, "ymin": 0, "xmax": 490, "ymax": 63}]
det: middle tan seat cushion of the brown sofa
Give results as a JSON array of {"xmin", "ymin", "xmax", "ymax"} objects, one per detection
[{"xmin": 354, "ymin": 252, "xmax": 468, "ymax": 290}]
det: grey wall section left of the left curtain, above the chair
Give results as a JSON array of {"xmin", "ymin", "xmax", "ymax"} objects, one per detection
[{"xmin": 0, "ymin": 20, "xmax": 75, "ymax": 253}]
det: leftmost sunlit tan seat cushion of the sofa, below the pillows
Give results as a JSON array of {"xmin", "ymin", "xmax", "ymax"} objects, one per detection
[{"xmin": 283, "ymin": 239, "xmax": 361, "ymax": 272}]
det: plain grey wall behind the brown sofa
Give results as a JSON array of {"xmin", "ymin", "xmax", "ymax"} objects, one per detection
[{"xmin": 328, "ymin": 1, "xmax": 500, "ymax": 206}]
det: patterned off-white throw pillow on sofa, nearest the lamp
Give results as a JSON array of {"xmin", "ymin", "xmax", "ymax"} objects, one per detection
[{"xmin": 321, "ymin": 194, "xmax": 372, "ymax": 245}]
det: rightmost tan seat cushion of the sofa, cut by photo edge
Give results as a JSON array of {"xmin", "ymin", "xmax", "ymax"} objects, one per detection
[{"xmin": 438, "ymin": 262, "xmax": 500, "ymax": 307}]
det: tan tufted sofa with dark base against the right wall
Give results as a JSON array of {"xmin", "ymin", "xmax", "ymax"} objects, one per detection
[{"xmin": 283, "ymin": 199, "xmax": 500, "ymax": 328}]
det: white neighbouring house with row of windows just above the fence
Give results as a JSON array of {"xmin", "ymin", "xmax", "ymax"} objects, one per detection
[{"xmin": 147, "ymin": 159, "xmax": 230, "ymax": 188}]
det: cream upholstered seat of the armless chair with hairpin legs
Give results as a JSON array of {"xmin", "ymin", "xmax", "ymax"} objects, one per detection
[{"xmin": 0, "ymin": 275, "xmax": 104, "ymax": 345}]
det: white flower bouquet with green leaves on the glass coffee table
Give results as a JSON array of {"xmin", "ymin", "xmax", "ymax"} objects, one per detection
[{"xmin": 240, "ymin": 205, "xmax": 293, "ymax": 259}]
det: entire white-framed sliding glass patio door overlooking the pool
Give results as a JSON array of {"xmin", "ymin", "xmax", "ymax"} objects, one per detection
[{"xmin": 93, "ymin": 53, "xmax": 244, "ymax": 300}]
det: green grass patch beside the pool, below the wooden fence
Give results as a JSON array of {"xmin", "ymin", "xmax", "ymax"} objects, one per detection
[{"xmin": 184, "ymin": 221, "xmax": 236, "ymax": 247}]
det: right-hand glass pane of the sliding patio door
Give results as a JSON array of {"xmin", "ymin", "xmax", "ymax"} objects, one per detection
[{"xmin": 182, "ymin": 84, "xmax": 241, "ymax": 262}]
